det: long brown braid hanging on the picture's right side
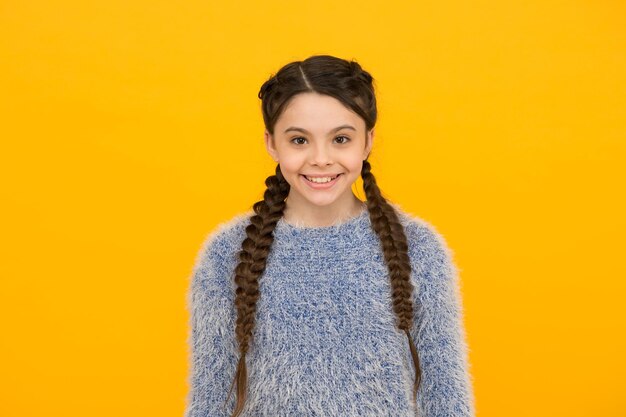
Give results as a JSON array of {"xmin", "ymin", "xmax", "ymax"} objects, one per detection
[{"xmin": 361, "ymin": 160, "xmax": 421, "ymax": 402}]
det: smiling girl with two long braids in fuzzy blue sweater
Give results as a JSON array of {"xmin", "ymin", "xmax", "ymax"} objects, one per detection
[{"xmin": 185, "ymin": 55, "xmax": 474, "ymax": 417}]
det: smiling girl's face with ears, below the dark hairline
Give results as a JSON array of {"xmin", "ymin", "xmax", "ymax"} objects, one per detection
[{"xmin": 265, "ymin": 93, "xmax": 374, "ymax": 209}]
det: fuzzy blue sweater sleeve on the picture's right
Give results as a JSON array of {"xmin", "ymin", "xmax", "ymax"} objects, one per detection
[{"xmin": 409, "ymin": 225, "xmax": 475, "ymax": 417}]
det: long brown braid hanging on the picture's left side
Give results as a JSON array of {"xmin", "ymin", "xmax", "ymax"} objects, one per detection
[{"xmin": 224, "ymin": 165, "xmax": 290, "ymax": 417}]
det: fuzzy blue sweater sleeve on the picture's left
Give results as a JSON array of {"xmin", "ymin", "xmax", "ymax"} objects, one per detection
[{"xmin": 184, "ymin": 232, "xmax": 236, "ymax": 417}]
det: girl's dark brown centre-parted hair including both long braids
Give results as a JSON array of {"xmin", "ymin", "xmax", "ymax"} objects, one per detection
[{"xmin": 226, "ymin": 55, "xmax": 421, "ymax": 417}]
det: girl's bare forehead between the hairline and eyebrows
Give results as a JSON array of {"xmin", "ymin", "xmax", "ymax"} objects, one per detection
[{"xmin": 276, "ymin": 93, "xmax": 365, "ymax": 129}]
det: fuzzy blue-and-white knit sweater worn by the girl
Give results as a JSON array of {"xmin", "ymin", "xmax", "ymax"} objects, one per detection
[{"xmin": 185, "ymin": 204, "xmax": 475, "ymax": 417}]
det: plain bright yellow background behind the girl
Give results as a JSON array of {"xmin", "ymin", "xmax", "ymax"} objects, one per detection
[{"xmin": 0, "ymin": 0, "xmax": 626, "ymax": 417}]
